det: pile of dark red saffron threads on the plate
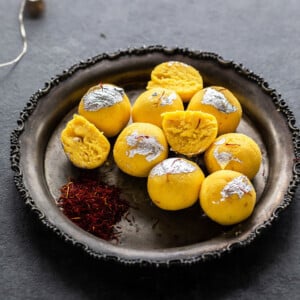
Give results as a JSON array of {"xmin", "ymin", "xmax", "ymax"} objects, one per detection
[{"xmin": 58, "ymin": 176, "xmax": 129, "ymax": 240}]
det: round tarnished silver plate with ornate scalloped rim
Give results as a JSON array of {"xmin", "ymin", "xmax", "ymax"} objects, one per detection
[{"xmin": 11, "ymin": 46, "xmax": 300, "ymax": 265}]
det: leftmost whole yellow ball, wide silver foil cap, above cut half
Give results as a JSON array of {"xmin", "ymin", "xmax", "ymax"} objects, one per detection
[{"xmin": 78, "ymin": 84, "xmax": 131, "ymax": 137}]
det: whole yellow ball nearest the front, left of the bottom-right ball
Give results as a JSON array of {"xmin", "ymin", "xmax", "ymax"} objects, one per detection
[{"xmin": 147, "ymin": 157, "xmax": 204, "ymax": 211}]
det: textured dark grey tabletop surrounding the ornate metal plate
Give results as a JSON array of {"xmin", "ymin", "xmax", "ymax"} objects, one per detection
[{"xmin": 0, "ymin": 0, "xmax": 300, "ymax": 300}]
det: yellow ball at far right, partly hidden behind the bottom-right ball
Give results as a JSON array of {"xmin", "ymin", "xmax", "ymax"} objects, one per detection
[{"xmin": 204, "ymin": 133, "xmax": 262, "ymax": 180}]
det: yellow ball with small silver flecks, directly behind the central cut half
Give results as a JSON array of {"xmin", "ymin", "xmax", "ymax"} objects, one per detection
[{"xmin": 132, "ymin": 87, "xmax": 184, "ymax": 127}]
